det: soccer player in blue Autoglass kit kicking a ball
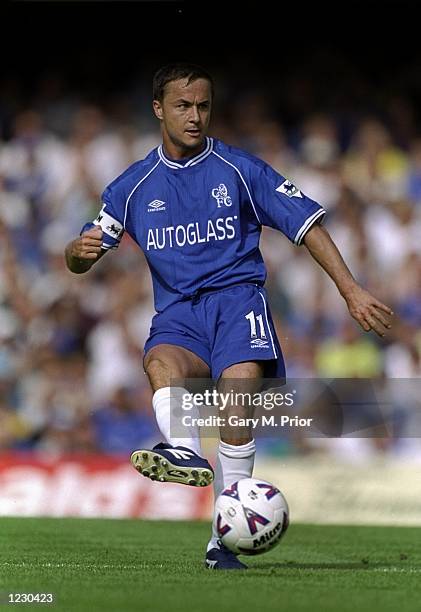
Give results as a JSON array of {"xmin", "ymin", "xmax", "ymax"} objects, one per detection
[{"xmin": 65, "ymin": 64, "xmax": 392, "ymax": 569}]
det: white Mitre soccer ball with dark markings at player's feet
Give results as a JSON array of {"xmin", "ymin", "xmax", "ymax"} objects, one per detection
[{"xmin": 213, "ymin": 478, "xmax": 289, "ymax": 555}]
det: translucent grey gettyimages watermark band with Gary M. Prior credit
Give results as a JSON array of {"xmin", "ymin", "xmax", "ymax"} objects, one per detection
[{"xmin": 170, "ymin": 377, "xmax": 421, "ymax": 438}]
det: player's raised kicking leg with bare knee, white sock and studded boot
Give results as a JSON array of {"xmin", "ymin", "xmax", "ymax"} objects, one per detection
[{"xmin": 131, "ymin": 344, "xmax": 214, "ymax": 486}]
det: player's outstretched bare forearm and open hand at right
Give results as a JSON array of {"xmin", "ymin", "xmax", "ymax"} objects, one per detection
[{"xmin": 303, "ymin": 223, "xmax": 393, "ymax": 336}]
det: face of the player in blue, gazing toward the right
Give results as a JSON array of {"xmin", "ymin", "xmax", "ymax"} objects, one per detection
[{"xmin": 153, "ymin": 79, "xmax": 212, "ymax": 159}]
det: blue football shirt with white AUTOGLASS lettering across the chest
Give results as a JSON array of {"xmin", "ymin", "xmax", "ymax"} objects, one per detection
[{"xmin": 86, "ymin": 138, "xmax": 325, "ymax": 312}]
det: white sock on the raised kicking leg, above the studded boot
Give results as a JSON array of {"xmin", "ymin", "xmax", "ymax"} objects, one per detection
[{"xmin": 152, "ymin": 387, "xmax": 202, "ymax": 455}]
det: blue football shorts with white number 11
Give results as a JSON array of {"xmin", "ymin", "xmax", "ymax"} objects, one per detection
[{"xmin": 145, "ymin": 283, "xmax": 285, "ymax": 380}]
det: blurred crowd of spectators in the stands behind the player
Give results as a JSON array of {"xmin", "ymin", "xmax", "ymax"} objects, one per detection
[{"xmin": 0, "ymin": 1, "xmax": 421, "ymax": 454}]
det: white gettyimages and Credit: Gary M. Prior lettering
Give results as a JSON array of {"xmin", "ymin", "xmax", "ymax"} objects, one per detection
[{"xmin": 181, "ymin": 389, "xmax": 313, "ymax": 429}]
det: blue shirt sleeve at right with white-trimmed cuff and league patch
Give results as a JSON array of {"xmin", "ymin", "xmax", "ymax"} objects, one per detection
[{"xmin": 251, "ymin": 164, "xmax": 326, "ymax": 245}]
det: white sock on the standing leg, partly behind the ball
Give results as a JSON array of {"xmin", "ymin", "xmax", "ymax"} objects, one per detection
[{"xmin": 207, "ymin": 440, "xmax": 256, "ymax": 550}]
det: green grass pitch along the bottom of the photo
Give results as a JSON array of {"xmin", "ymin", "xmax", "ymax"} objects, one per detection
[{"xmin": 0, "ymin": 518, "xmax": 421, "ymax": 612}]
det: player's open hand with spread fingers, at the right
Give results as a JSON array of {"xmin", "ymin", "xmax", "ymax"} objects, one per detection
[{"xmin": 344, "ymin": 285, "xmax": 393, "ymax": 338}]
